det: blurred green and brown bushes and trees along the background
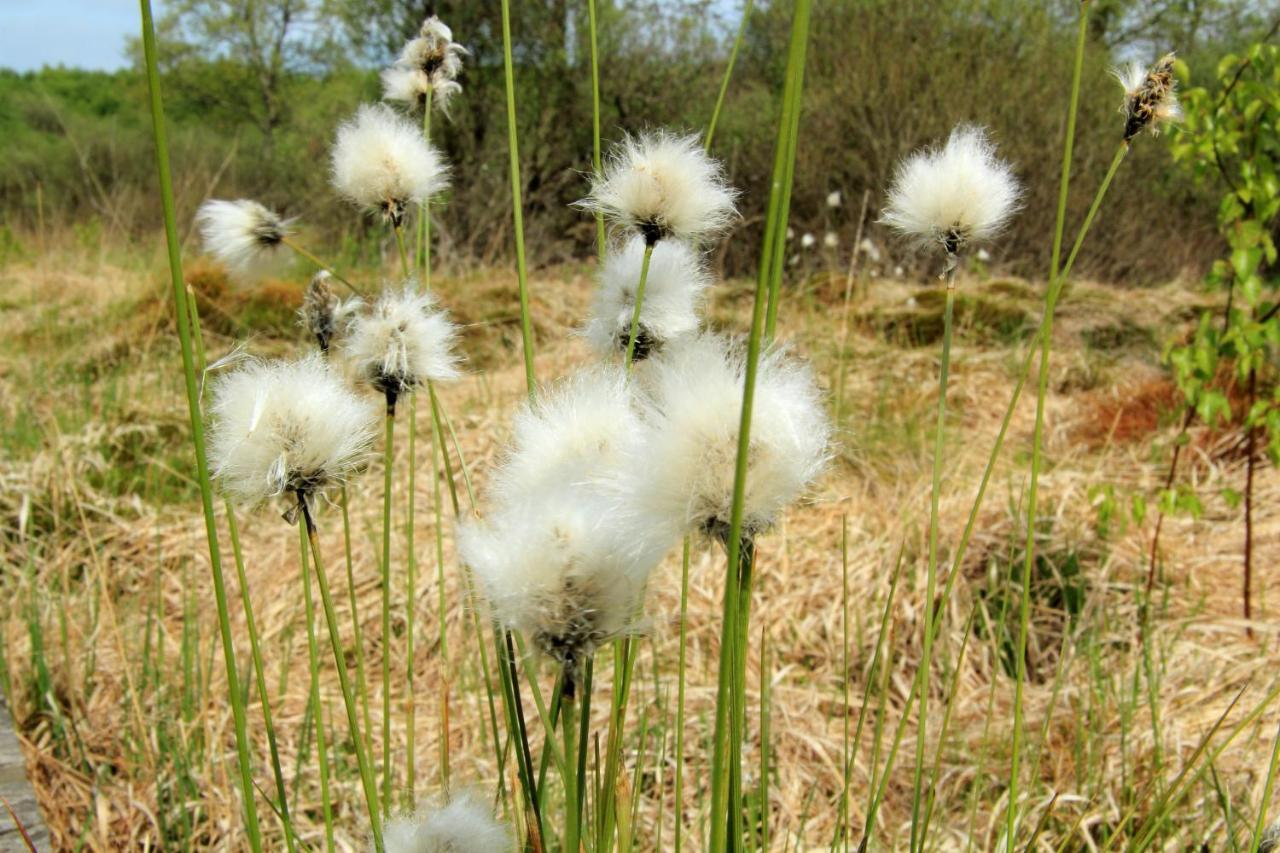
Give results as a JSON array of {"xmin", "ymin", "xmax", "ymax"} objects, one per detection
[{"xmin": 0, "ymin": 0, "xmax": 1280, "ymax": 284}]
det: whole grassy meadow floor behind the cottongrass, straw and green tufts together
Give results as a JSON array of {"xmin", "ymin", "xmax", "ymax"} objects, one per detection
[{"xmin": 0, "ymin": 230, "xmax": 1280, "ymax": 849}]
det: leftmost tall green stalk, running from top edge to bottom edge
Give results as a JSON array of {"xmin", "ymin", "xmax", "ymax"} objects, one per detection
[{"xmin": 138, "ymin": 0, "xmax": 262, "ymax": 853}]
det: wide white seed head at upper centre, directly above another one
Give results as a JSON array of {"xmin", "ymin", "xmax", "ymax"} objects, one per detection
[{"xmin": 579, "ymin": 131, "xmax": 737, "ymax": 242}]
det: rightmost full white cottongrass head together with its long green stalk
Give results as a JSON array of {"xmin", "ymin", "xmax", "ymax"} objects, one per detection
[{"xmin": 882, "ymin": 124, "xmax": 1021, "ymax": 848}]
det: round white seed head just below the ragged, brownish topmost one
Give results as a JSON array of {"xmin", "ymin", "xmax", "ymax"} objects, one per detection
[{"xmin": 333, "ymin": 104, "xmax": 448, "ymax": 225}]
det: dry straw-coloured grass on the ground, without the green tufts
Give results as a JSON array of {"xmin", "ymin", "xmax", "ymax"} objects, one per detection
[{"xmin": 0, "ymin": 247, "xmax": 1280, "ymax": 850}]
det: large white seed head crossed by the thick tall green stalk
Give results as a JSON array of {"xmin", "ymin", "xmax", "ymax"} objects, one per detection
[{"xmin": 628, "ymin": 333, "xmax": 831, "ymax": 538}]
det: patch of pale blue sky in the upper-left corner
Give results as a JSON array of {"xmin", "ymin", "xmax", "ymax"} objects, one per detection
[{"xmin": 0, "ymin": 0, "xmax": 151, "ymax": 70}]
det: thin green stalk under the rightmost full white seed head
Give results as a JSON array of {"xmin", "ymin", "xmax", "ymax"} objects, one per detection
[{"xmin": 911, "ymin": 263, "xmax": 959, "ymax": 850}]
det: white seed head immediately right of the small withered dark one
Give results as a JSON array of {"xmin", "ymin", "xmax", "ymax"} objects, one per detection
[{"xmin": 343, "ymin": 286, "xmax": 458, "ymax": 414}]
